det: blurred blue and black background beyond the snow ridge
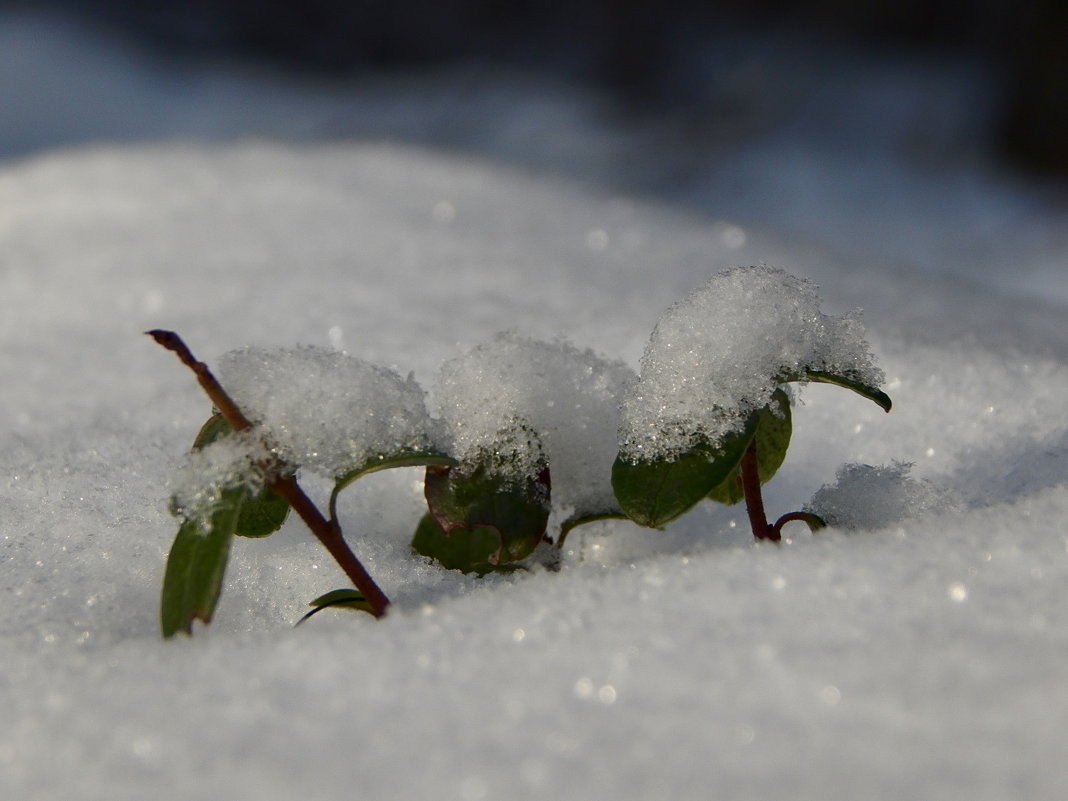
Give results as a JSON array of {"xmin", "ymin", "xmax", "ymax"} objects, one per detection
[{"xmin": 0, "ymin": 0, "xmax": 1068, "ymax": 303}]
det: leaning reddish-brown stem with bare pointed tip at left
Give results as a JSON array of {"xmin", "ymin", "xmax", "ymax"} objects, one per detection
[{"xmin": 147, "ymin": 330, "xmax": 390, "ymax": 617}]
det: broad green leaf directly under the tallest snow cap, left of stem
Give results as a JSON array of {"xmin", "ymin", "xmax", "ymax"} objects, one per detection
[{"xmin": 612, "ymin": 419, "xmax": 754, "ymax": 529}]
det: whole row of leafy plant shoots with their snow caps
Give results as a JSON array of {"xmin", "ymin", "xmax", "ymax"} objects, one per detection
[{"xmin": 150, "ymin": 267, "xmax": 891, "ymax": 637}]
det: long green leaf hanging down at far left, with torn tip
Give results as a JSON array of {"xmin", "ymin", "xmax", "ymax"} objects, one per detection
[{"xmin": 159, "ymin": 487, "xmax": 249, "ymax": 638}]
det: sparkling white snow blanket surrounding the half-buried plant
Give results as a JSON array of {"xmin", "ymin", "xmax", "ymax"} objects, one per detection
[{"xmin": 0, "ymin": 10, "xmax": 1068, "ymax": 801}]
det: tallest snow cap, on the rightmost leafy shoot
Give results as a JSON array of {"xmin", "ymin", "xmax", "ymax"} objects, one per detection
[{"xmin": 619, "ymin": 266, "xmax": 883, "ymax": 460}]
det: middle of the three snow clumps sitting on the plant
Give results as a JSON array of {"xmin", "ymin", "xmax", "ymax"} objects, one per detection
[{"xmin": 435, "ymin": 332, "xmax": 635, "ymax": 511}]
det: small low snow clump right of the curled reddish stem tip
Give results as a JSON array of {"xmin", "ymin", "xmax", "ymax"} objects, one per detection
[{"xmin": 805, "ymin": 461, "xmax": 957, "ymax": 531}]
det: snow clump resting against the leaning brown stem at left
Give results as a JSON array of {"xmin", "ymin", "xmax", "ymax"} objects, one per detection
[{"xmin": 219, "ymin": 347, "xmax": 433, "ymax": 476}]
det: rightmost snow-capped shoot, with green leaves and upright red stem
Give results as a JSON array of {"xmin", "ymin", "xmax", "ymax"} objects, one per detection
[{"xmin": 612, "ymin": 267, "xmax": 891, "ymax": 540}]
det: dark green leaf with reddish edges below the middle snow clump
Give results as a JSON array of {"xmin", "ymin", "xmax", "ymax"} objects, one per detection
[{"xmin": 420, "ymin": 465, "xmax": 549, "ymax": 569}]
